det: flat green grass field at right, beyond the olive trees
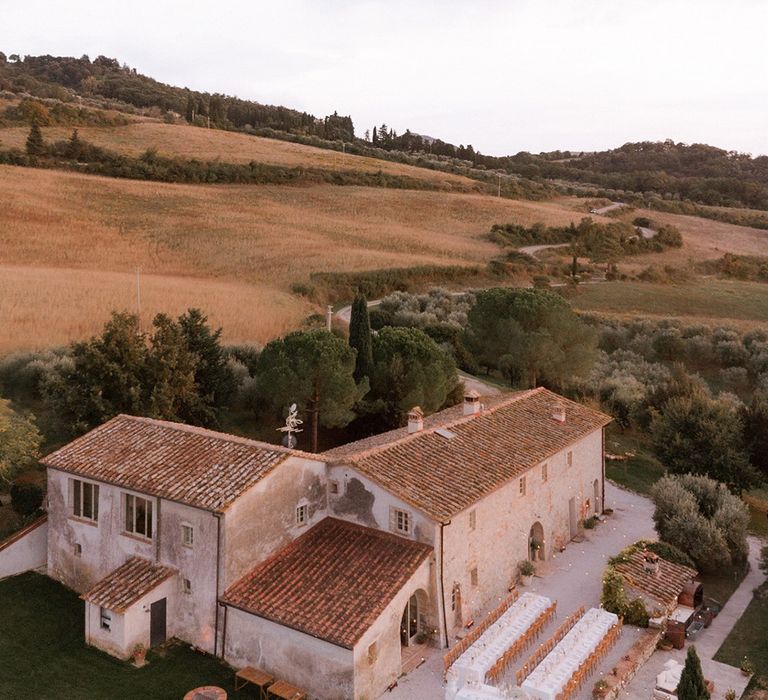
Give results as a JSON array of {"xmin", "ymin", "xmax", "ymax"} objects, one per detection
[{"xmin": 571, "ymin": 279, "xmax": 768, "ymax": 323}]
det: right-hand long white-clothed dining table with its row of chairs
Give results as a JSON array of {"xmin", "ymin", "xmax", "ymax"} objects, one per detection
[{"xmin": 522, "ymin": 608, "xmax": 622, "ymax": 700}]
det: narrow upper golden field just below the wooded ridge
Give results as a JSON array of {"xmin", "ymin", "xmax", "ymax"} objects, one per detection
[{"xmin": 0, "ymin": 121, "xmax": 477, "ymax": 187}]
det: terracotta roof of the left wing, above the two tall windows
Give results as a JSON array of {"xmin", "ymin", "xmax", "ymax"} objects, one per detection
[{"xmin": 41, "ymin": 415, "xmax": 317, "ymax": 511}]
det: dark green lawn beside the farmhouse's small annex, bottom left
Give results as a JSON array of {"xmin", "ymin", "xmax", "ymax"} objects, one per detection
[{"xmin": 0, "ymin": 573, "xmax": 248, "ymax": 700}]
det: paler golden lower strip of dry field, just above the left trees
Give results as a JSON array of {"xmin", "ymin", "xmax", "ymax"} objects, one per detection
[{"xmin": 0, "ymin": 265, "xmax": 311, "ymax": 354}]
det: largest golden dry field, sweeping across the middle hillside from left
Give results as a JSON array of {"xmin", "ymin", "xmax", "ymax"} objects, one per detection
[{"xmin": 0, "ymin": 167, "xmax": 574, "ymax": 351}]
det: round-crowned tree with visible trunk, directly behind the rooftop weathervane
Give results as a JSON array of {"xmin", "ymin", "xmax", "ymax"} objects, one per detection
[{"xmin": 256, "ymin": 329, "xmax": 369, "ymax": 452}]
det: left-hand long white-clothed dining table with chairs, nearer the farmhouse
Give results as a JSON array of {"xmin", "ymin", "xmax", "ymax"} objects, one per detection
[{"xmin": 446, "ymin": 593, "xmax": 557, "ymax": 698}]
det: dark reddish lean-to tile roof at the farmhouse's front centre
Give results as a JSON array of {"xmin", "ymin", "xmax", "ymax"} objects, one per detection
[{"xmin": 222, "ymin": 518, "xmax": 432, "ymax": 649}]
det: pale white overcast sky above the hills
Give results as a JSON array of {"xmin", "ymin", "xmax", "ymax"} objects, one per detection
[{"xmin": 0, "ymin": 0, "xmax": 768, "ymax": 155}]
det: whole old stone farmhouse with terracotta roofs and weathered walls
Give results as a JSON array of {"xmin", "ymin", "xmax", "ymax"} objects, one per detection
[{"xmin": 37, "ymin": 389, "xmax": 610, "ymax": 699}]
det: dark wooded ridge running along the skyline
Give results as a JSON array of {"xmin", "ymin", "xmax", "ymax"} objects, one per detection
[{"xmin": 0, "ymin": 52, "xmax": 768, "ymax": 211}]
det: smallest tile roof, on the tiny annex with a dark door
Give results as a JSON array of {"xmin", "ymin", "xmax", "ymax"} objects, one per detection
[{"xmin": 80, "ymin": 557, "xmax": 176, "ymax": 613}]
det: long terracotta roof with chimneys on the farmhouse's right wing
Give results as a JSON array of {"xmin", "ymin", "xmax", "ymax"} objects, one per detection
[{"xmin": 323, "ymin": 388, "xmax": 611, "ymax": 522}]
